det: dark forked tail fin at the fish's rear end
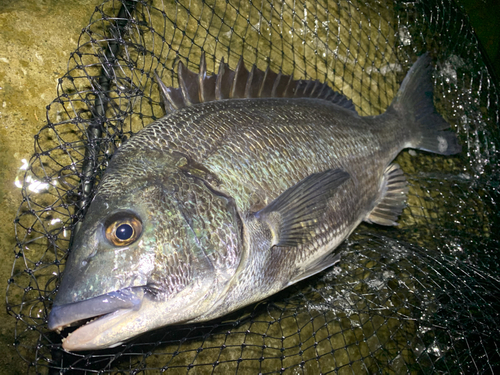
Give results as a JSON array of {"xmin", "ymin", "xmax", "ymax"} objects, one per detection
[{"xmin": 391, "ymin": 53, "xmax": 462, "ymax": 155}]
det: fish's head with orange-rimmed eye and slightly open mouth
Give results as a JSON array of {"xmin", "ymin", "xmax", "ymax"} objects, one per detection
[{"xmin": 48, "ymin": 150, "xmax": 243, "ymax": 350}]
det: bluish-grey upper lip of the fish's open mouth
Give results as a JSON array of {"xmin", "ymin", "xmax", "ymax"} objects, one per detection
[{"xmin": 48, "ymin": 286, "xmax": 144, "ymax": 331}]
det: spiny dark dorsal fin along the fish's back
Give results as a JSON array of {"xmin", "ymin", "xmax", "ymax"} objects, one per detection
[{"xmin": 155, "ymin": 53, "xmax": 356, "ymax": 113}]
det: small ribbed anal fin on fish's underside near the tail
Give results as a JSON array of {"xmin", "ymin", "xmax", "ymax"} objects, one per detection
[{"xmin": 365, "ymin": 164, "xmax": 408, "ymax": 225}]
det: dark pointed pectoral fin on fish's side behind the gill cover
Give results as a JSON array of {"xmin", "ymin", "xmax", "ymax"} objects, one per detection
[{"xmin": 254, "ymin": 169, "xmax": 349, "ymax": 247}]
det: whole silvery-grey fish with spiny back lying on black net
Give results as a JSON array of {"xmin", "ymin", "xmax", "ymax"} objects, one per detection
[{"xmin": 48, "ymin": 54, "xmax": 461, "ymax": 351}]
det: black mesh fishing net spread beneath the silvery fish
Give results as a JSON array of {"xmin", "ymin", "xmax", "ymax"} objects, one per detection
[{"xmin": 7, "ymin": 0, "xmax": 500, "ymax": 374}]
